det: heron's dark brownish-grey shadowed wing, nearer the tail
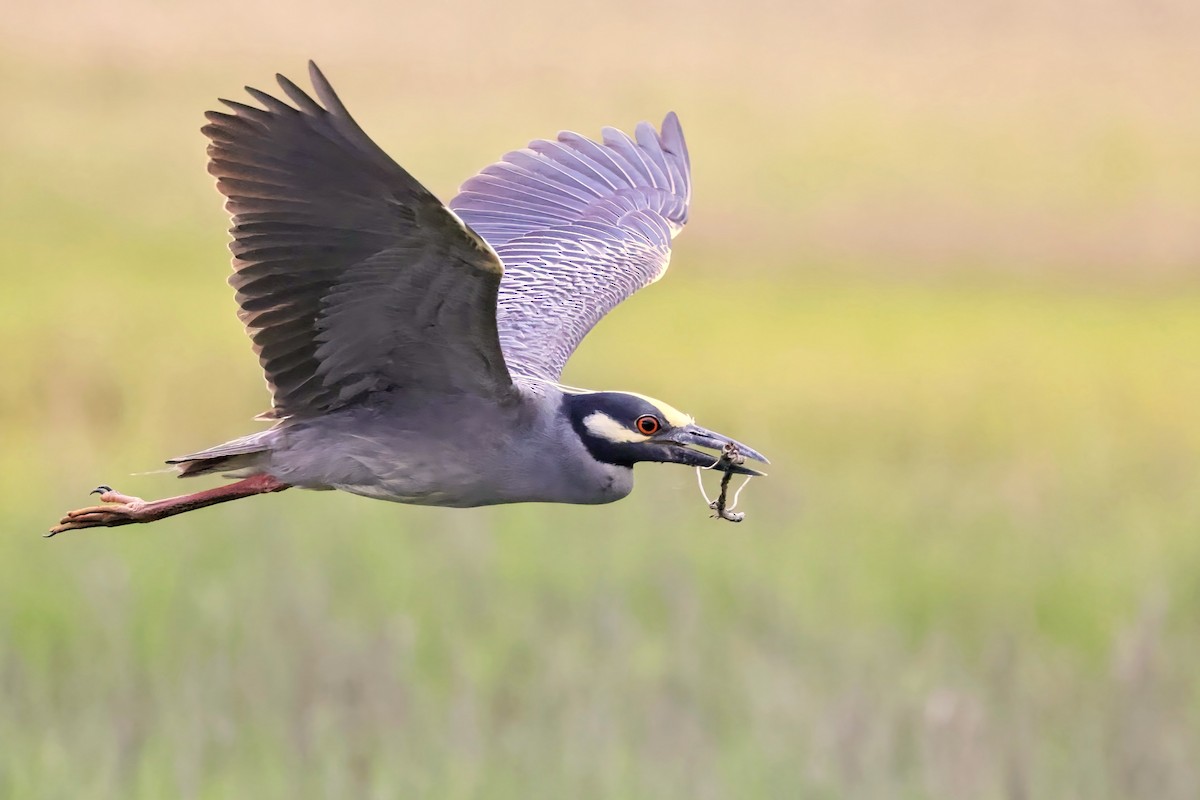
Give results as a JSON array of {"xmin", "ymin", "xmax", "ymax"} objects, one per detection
[{"xmin": 204, "ymin": 62, "xmax": 512, "ymax": 417}]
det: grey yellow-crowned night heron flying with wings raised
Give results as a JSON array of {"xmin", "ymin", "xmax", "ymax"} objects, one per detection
[{"xmin": 50, "ymin": 64, "xmax": 766, "ymax": 534}]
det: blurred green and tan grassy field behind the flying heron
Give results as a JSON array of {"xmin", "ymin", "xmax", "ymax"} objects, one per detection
[{"xmin": 0, "ymin": 0, "xmax": 1200, "ymax": 800}]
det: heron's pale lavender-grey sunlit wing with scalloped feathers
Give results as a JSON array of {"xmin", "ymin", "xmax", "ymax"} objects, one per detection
[{"xmin": 450, "ymin": 114, "xmax": 691, "ymax": 380}]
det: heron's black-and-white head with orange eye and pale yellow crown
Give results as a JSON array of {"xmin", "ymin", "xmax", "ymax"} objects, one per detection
[{"xmin": 563, "ymin": 392, "xmax": 768, "ymax": 475}]
